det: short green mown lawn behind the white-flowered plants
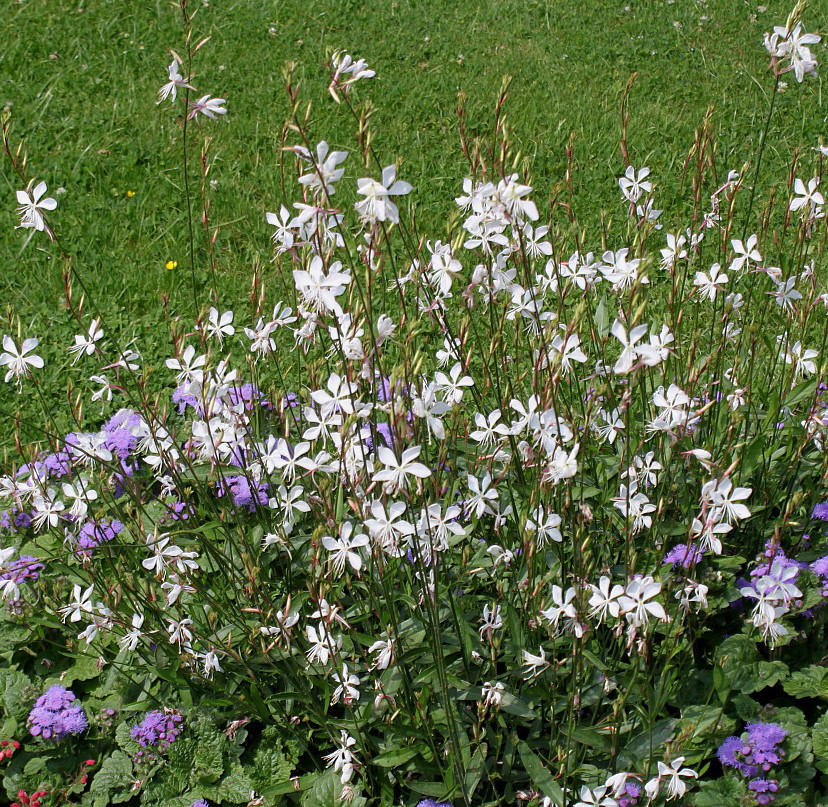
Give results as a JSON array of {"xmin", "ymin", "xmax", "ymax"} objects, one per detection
[{"xmin": 0, "ymin": 0, "xmax": 828, "ymax": 454}]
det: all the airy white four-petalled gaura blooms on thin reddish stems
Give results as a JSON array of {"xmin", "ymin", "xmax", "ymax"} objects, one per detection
[{"xmin": 9, "ymin": 22, "xmax": 828, "ymax": 807}]
